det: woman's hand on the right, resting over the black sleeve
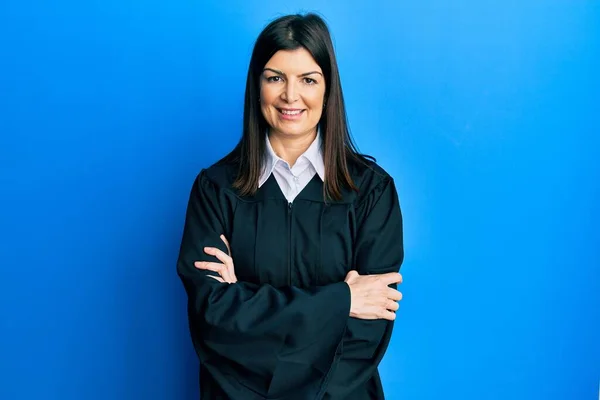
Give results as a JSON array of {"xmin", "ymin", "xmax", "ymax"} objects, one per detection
[{"xmin": 344, "ymin": 270, "xmax": 402, "ymax": 321}]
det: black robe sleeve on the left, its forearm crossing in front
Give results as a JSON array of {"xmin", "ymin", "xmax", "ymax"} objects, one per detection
[{"xmin": 177, "ymin": 171, "xmax": 350, "ymax": 398}]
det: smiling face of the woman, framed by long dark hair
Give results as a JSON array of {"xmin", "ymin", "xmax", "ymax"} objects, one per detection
[{"xmin": 260, "ymin": 47, "xmax": 325, "ymax": 136}]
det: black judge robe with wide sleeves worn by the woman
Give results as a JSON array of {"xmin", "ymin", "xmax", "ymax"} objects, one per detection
[{"xmin": 177, "ymin": 157, "xmax": 404, "ymax": 400}]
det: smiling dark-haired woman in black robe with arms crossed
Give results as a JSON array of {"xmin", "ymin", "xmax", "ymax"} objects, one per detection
[{"xmin": 177, "ymin": 14, "xmax": 403, "ymax": 400}]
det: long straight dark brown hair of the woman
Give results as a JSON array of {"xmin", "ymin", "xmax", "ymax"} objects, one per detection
[{"xmin": 220, "ymin": 13, "xmax": 374, "ymax": 200}]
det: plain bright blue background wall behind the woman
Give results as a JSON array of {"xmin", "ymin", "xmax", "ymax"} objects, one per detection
[{"xmin": 0, "ymin": 0, "xmax": 600, "ymax": 400}]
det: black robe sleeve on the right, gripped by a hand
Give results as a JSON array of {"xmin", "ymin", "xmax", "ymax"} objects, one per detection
[{"xmin": 324, "ymin": 178, "xmax": 404, "ymax": 399}]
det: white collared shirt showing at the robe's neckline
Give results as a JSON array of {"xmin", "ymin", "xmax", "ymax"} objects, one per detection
[{"xmin": 258, "ymin": 130, "xmax": 325, "ymax": 203}]
